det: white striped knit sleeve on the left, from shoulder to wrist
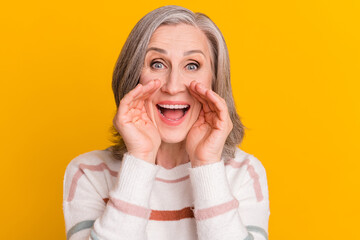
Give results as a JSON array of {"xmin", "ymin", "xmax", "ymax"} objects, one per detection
[{"xmin": 63, "ymin": 154, "xmax": 159, "ymax": 240}]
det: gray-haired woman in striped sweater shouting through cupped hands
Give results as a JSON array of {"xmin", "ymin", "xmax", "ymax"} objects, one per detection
[{"xmin": 63, "ymin": 6, "xmax": 269, "ymax": 240}]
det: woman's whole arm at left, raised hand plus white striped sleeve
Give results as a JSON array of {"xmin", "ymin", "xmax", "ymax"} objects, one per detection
[{"xmin": 64, "ymin": 80, "xmax": 161, "ymax": 240}]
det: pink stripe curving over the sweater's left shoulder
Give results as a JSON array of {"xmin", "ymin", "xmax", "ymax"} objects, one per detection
[{"xmin": 67, "ymin": 163, "xmax": 118, "ymax": 202}]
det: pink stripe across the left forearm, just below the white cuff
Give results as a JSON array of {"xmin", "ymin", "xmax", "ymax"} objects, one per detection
[{"xmin": 108, "ymin": 198, "xmax": 151, "ymax": 219}]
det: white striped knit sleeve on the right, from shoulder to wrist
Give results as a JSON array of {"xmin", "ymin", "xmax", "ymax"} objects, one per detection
[{"xmin": 189, "ymin": 156, "xmax": 270, "ymax": 240}]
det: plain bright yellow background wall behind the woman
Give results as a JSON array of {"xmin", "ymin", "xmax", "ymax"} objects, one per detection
[{"xmin": 0, "ymin": 0, "xmax": 360, "ymax": 240}]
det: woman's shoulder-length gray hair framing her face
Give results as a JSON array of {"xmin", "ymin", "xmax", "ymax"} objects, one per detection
[{"xmin": 111, "ymin": 5, "xmax": 244, "ymax": 160}]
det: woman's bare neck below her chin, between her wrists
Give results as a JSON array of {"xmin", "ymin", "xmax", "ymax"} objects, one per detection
[{"xmin": 156, "ymin": 141, "xmax": 189, "ymax": 169}]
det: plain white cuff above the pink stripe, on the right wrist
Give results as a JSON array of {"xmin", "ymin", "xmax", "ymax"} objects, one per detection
[{"xmin": 189, "ymin": 161, "xmax": 233, "ymax": 208}]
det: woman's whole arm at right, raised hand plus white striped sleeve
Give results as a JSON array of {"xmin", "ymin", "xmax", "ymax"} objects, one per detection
[{"xmin": 186, "ymin": 81, "xmax": 268, "ymax": 240}]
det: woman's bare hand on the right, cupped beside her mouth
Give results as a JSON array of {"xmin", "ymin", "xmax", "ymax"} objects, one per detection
[{"xmin": 186, "ymin": 81, "xmax": 233, "ymax": 167}]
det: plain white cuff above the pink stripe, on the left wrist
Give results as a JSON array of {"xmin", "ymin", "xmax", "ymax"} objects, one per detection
[{"xmin": 110, "ymin": 153, "xmax": 160, "ymax": 206}]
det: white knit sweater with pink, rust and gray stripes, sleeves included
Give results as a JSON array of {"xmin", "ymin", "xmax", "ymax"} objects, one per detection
[{"xmin": 63, "ymin": 149, "xmax": 270, "ymax": 240}]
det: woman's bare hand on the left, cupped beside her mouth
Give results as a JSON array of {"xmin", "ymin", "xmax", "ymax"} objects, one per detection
[{"xmin": 113, "ymin": 80, "xmax": 161, "ymax": 164}]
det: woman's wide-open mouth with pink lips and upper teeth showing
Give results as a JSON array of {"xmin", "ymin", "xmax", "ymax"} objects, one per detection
[{"xmin": 156, "ymin": 101, "xmax": 190, "ymax": 126}]
